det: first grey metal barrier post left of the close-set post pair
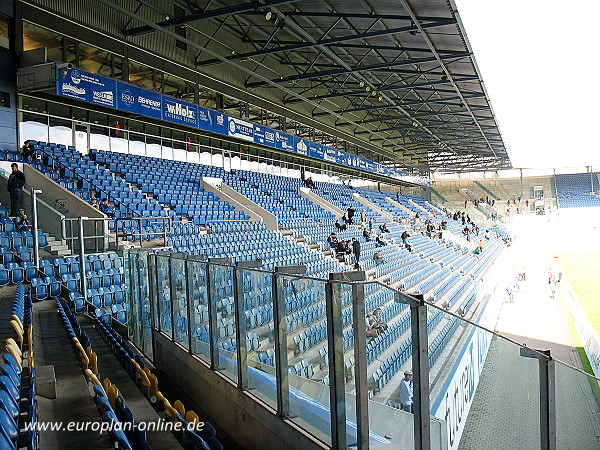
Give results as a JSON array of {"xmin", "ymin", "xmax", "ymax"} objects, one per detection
[{"xmin": 271, "ymin": 266, "xmax": 306, "ymax": 418}]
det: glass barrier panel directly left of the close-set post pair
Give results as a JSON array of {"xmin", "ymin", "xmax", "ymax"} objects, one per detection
[{"xmin": 282, "ymin": 275, "xmax": 331, "ymax": 444}]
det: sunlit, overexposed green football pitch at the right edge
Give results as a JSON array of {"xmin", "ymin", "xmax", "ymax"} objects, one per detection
[{"xmin": 559, "ymin": 253, "xmax": 600, "ymax": 336}]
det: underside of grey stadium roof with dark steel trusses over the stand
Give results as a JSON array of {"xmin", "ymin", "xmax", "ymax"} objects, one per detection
[{"xmin": 112, "ymin": 0, "xmax": 511, "ymax": 171}]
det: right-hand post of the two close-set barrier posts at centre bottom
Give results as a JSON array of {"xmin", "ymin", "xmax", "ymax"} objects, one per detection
[{"xmin": 352, "ymin": 283, "xmax": 369, "ymax": 450}]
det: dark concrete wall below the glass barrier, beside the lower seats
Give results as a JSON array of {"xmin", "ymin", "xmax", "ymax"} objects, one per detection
[{"xmin": 154, "ymin": 331, "xmax": 327, "ymax": 450}]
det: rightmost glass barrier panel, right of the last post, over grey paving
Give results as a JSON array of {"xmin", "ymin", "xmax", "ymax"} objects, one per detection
[{"xmin": 554, "ymin": 358, "xmax": 600, "ymax": 450}]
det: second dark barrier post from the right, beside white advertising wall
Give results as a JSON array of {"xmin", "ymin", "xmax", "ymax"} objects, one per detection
[{"xmin": 395, "ymin": 292, "xmax": 431, "ymax": 450}]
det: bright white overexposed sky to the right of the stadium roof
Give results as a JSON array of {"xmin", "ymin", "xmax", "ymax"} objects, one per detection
[{"xmin": 455, "ymin": 0, "xmax": 600, "ymax": 170}]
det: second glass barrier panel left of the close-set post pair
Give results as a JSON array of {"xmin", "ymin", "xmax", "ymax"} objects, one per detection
[{"xmin": 237, "ymin": 269, "xmax": 277, "ymax": 408}]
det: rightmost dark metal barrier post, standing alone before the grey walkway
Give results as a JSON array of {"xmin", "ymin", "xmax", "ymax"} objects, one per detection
[{"xmin": 520, "ymin": 347, "xmax": 556, "ymax": 450}]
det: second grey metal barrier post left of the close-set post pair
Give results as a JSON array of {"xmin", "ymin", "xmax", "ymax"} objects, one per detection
[{"xmin": 233, "ymin": 260, "xmax": 262, "ymax": 390}]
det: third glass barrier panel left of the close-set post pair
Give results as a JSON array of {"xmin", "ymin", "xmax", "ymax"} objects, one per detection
[{"xmin": 209, "ymin": 264, "xmax": 237, "ymax": 381}]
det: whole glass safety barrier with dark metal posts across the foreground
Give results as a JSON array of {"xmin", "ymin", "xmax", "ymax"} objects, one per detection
[{"xmin": 124, "ymin": 249, "xmax": 600, "ymax": 449}]
